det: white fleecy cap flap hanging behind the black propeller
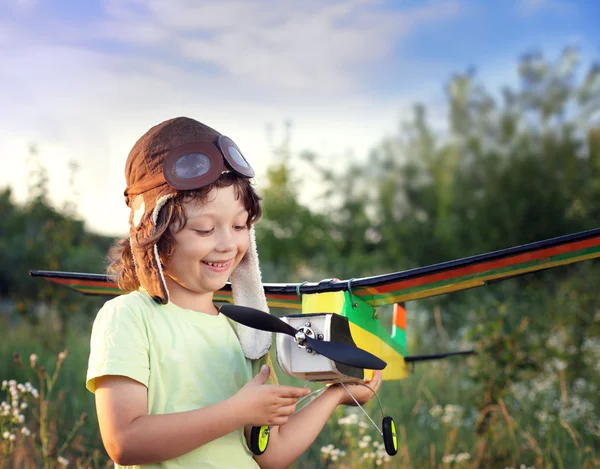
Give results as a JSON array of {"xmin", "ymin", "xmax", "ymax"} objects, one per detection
[{"xmin": 231, "ymin": 227, "xmax": 273, "ymax": 360}]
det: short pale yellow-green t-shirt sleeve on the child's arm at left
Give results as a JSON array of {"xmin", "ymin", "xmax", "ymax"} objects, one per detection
[{"xmin": 86, "ymin": 300, "xmax": 150, "ymax": 393}]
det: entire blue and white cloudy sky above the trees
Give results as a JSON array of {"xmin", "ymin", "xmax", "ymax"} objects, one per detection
[{"xmin": 0, "ymin": 0, "xmax": 600, "ymax": 234}]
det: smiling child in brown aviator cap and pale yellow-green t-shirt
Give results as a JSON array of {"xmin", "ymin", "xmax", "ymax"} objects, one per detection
[{"xmin": 87, "ymin": 117, "xmax": 381, "ymax": 469}]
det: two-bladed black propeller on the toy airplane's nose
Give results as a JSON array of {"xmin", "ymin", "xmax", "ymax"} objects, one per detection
[{"xmin": 219, "ymin": 304, "xmax": 387, "ymax": 370}]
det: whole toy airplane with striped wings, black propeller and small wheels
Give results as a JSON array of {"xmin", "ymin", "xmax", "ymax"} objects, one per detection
[{"xmin": 30, "ymin": 229, "xmax": 600, "ymax": 454}]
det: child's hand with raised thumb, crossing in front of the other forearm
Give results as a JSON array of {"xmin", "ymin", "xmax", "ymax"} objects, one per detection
[{"xmin": 231, "ymin": 365, "xmax": 310, "ymax": 426}]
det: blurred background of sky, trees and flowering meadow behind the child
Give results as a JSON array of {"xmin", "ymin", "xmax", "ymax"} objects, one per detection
[{"xmin": 0, "ymin": 0, "xmax": 600, "ymax": 469}]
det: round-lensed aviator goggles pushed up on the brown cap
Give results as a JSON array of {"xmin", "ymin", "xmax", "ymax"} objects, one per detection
[{"xmin": 125, "ymin": 135, "xmax": 254, "ymax": 197}]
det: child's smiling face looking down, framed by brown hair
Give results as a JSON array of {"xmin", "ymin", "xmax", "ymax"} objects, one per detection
[{"xmin": 165, "ymin": 186, "xmax": 249, "ymax": 300}]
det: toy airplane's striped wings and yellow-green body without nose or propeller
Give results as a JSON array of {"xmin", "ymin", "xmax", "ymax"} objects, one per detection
[{"xmin": 30, "ymin": 229, "xmax": 600, "ymax": 380}]
